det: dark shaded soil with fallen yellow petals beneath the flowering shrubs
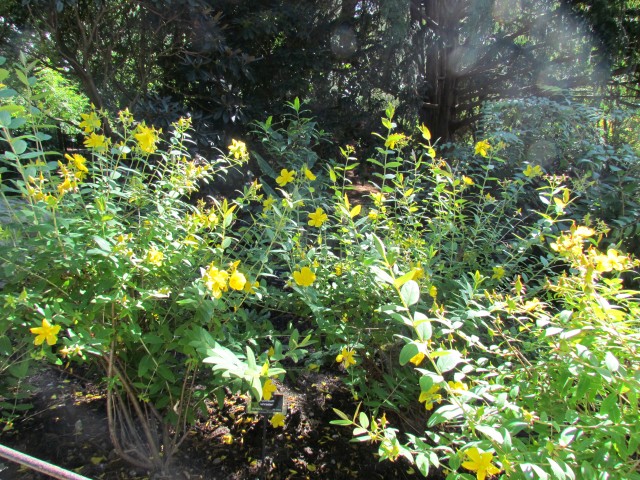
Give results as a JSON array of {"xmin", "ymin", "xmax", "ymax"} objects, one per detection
[{"xmin": 0, "ymin": 367, "xmax": 423, "ymax": 480}]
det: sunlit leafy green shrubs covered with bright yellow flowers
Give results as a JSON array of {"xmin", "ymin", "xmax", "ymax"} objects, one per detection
[{"xmin": 0, "ymin": 54, "xmax": 640, "ymax": 480}]
